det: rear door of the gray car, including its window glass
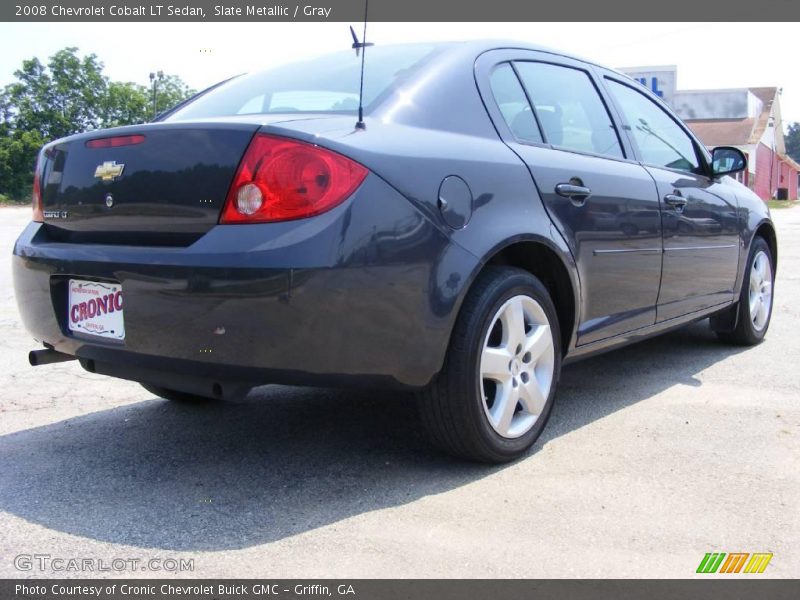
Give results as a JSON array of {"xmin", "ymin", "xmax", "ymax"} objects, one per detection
[{"xmin": 478, "ymin": 52, "xmax": 662, "ymax": 345}]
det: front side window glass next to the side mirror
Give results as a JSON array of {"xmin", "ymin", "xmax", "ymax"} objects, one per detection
[{"xmin": 606, "ymin": 79, "xmax": 700, "ymax": 173}]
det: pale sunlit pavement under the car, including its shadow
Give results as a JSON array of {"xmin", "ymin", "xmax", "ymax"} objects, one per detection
[{"xmin": 0, "ymin": 208, "xmax": 800, "ymax": 578}]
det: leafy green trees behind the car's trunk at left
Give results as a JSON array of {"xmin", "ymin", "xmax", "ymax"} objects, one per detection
[{"xmin": 0, "ymin": 48, "xmax": 194, "ymax": 198}]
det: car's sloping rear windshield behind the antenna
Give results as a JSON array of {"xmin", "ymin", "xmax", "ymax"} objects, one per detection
[{"xmin": 166, "ymin": 44, "xmax": 443, "ymax": 121}]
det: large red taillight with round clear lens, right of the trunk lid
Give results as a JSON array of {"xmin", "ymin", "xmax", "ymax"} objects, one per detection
[{"xmin": 220, "ymin": 134, "xmax": 367, "ymax": 223}]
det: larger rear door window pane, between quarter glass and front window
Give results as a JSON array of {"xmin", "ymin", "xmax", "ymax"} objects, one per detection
[{"xmin": 514, "ymin": 62, "xmax": 624, "ymax": 158}]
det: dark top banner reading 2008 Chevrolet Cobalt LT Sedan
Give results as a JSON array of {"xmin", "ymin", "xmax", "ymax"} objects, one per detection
[{"xmin": 0, "ymin": 0, "xmax": 800, "ymax": 22}]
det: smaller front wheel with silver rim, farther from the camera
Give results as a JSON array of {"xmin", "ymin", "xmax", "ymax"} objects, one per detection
[{"xmin": 716, "ymin": 237, "xmax": 775, "ymax": 346}]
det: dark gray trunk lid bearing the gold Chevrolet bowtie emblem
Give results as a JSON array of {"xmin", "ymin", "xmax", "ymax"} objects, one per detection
[{"xmin": 41, "ymin": 115, "xmax": 304, "ymax": 245}]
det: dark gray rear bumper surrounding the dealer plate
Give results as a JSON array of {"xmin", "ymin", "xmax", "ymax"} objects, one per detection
[{"xmin": 13, "ymin": 177, "xmax": 477, "ymax": 392}]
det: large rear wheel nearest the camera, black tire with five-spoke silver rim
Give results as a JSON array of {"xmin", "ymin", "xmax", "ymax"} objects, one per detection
[{"xmin": 419, "ymin": 267, "xmax": 561, "ymax": 463}]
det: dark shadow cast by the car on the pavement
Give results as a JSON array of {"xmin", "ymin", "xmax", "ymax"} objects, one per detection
[{"xmin": 0, "ymin": 322, "xmax": 742, "ymax": 551}]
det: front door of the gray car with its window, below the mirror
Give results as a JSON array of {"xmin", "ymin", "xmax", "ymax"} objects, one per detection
[{"xmin": 605, "ymin": 76, "xmax": 739, "ymax": 321}]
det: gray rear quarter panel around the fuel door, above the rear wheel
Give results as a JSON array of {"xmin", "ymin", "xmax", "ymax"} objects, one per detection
[{"xmin": 268, "ymin": 52, "xmax": 580, "ymax": 354}]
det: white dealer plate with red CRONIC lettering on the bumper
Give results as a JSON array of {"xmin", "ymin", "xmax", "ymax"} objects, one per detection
[{"xmin": 67, "ymin": 279, "xmax": 125, "ymax": 340}]
